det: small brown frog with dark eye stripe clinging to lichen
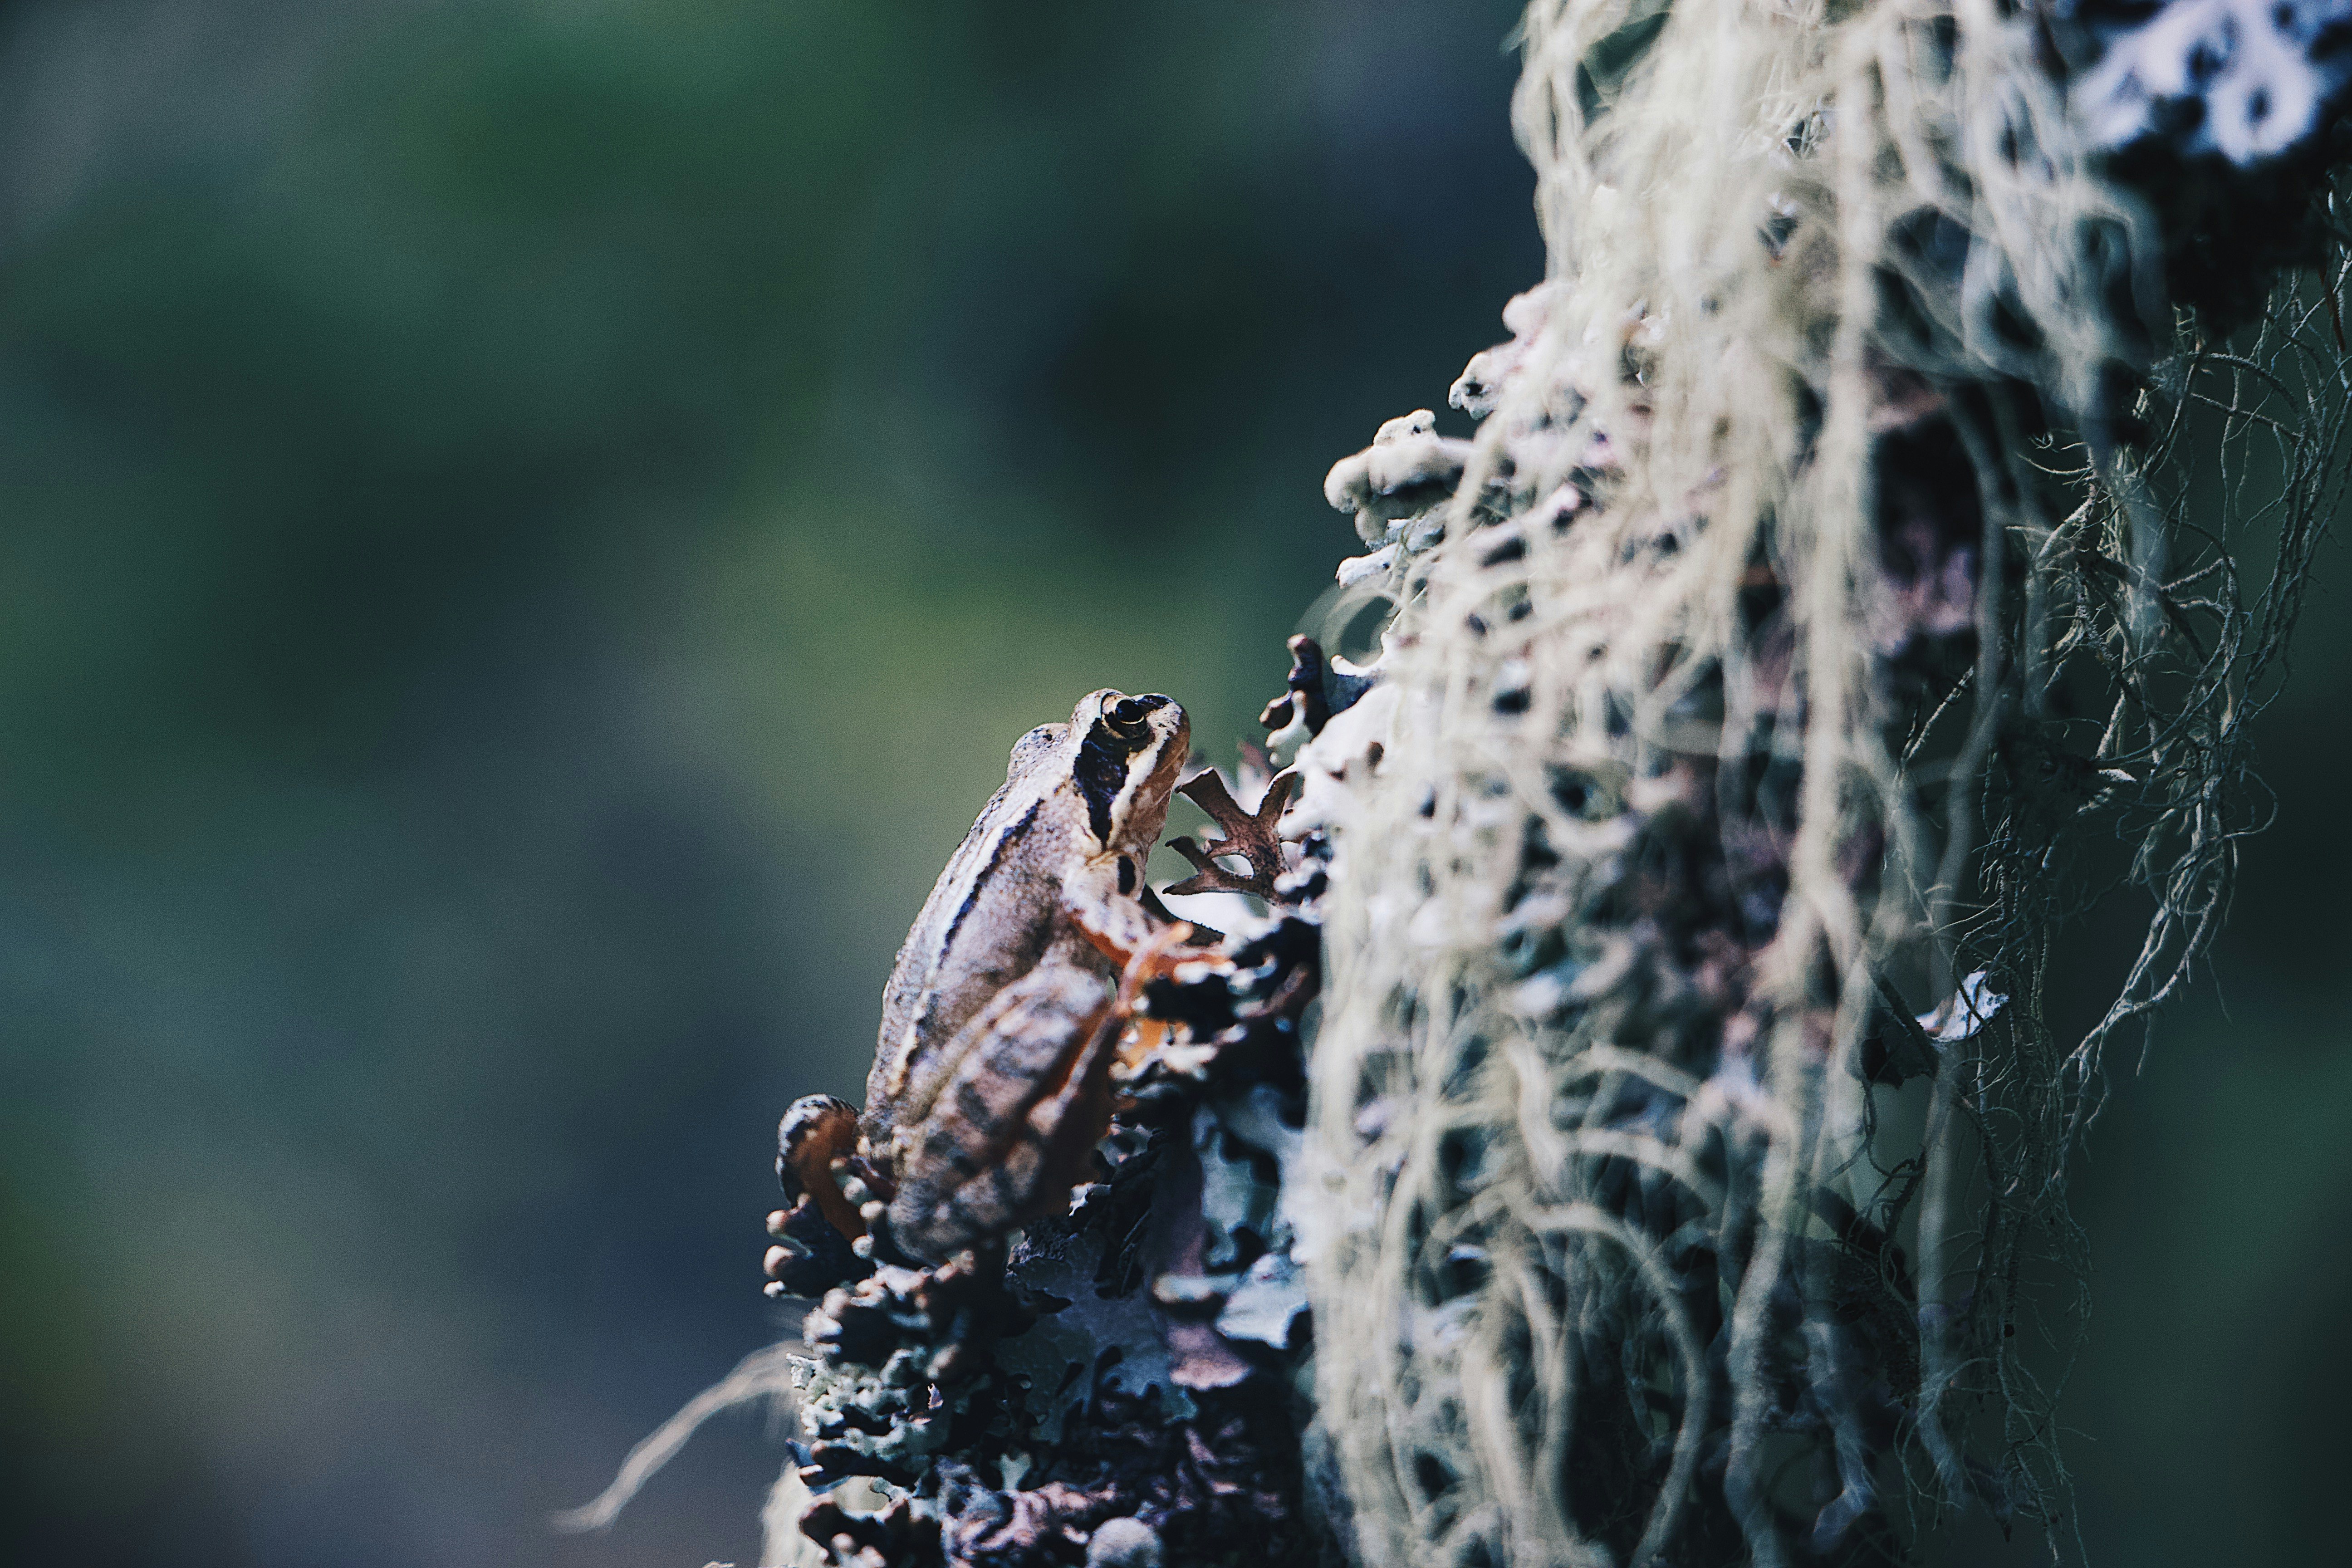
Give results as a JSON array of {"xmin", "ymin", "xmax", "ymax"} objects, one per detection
[{"xmin": 858, "ymin": 691, "xmax": 1190, "ymax": 1260}]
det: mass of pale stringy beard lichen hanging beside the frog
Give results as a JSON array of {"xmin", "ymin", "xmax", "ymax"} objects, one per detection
[{"xmin": 1298, "ymin": 0, "xmax": 2345, "ymax": 1568}]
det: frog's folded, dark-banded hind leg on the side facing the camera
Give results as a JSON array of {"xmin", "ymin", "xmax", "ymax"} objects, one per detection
[{"xmin": 889, "ymin": 957, "xmax": 1120, "ymax": 1258}]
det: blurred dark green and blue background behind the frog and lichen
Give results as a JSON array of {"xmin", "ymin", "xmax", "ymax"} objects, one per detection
[{"xmin": 0, "ymin": 0, "xmax": 2352, "ymax": 1568}]
